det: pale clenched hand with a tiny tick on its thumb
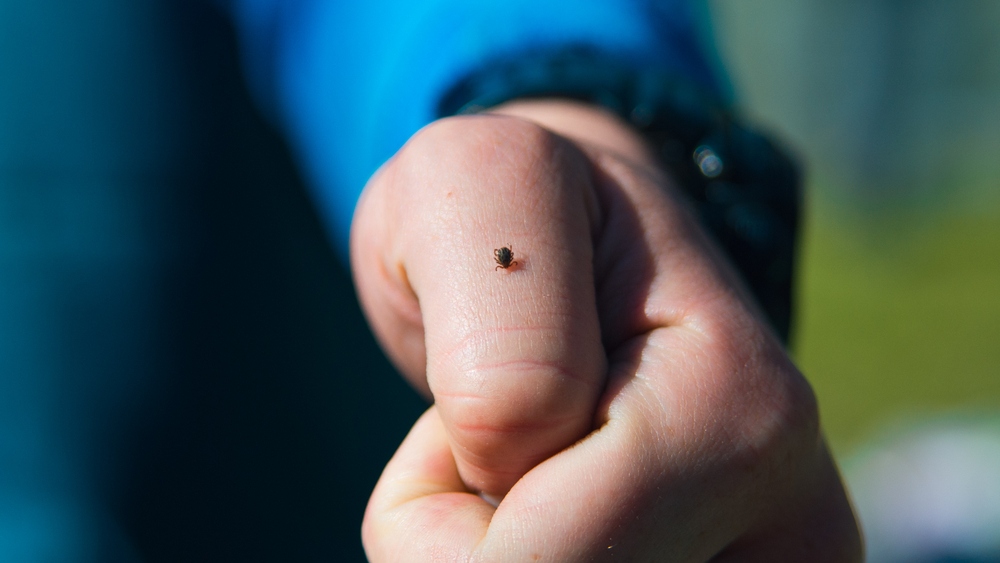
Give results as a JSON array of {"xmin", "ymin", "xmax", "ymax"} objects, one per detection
[{"xmin": 351, "ymin": 100, "xmax": 862, "ymax": 562}]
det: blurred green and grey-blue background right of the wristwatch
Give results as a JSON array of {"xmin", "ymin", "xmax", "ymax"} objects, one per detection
[{"xmin": 708, "ymin": 0, "xmax": 1000, "ymax": 457}]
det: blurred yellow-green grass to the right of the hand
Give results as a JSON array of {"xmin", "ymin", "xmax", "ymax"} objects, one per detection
[{"xmin": 792, "ymin": 198, "xmax": 1000, "ymax": 456}]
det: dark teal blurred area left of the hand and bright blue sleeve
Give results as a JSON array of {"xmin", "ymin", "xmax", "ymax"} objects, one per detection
[{"xmin": 0, "ymin": 0, "xmax": 425, "ymax": 561}]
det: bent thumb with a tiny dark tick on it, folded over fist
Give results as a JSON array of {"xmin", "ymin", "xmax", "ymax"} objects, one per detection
[{"xmin": 352, "ymin": 116, "xmax": 606, "ymax": 498}]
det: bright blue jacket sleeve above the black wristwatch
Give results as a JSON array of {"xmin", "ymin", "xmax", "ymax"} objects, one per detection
[{"xmin": 230, "ymin": 0, "xmax": 720, "ymax": 251}]
